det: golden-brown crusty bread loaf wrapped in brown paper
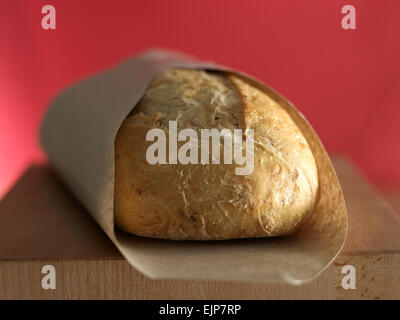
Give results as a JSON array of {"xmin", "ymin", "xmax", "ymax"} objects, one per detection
[{"xmin": 114, "ymin": 69, "xmax": 318, "ymax": 240}]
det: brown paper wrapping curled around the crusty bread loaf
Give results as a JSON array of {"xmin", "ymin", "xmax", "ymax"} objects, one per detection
[{"xmin": 41, "ymin": 50, "xmax": 347, "ymax": 284}]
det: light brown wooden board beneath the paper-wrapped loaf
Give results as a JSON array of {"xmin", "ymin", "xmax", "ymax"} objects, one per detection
[{"xmin": 0, "ymin": 157, "xmax": 400, "ymax": 299}]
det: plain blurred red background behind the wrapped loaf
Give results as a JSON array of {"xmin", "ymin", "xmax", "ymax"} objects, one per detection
[{"xmin": 0, "ymin": 0, "xmax": 400, "ymax": 195}]
